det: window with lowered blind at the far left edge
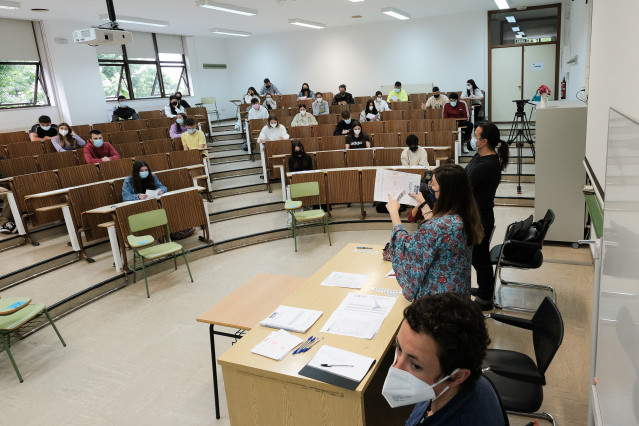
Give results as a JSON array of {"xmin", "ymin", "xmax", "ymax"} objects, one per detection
[{"xmin": 0, "ymin": 18, "xmax": 50, "ymax": 108}]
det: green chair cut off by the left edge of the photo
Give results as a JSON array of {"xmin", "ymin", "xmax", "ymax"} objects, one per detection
[{"xmin": 0, "ymin": 297, "xmax": 67, "ymax": 383}]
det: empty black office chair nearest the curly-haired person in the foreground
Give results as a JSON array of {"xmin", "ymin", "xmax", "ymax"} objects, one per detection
[{"xmin": 482, "ymin": 297, "xmax": 564, "ymax": 426}]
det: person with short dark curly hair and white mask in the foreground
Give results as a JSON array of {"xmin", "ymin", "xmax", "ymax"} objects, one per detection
[{"xmin": 382, "ymin": 293, "xmax": 506, "ymax": 426}]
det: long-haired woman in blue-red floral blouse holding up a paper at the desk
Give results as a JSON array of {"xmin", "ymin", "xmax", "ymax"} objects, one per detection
[{"xmin": 386, "ymin": 164, "xmax": 482, "ymax": 301}]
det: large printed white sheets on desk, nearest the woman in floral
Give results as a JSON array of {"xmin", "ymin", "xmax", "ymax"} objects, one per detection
[{"xmin": 321, "ymin": 293, "xmax": 396, "ymax": 339}]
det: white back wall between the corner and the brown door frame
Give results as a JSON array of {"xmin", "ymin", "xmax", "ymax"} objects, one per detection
[{"xmin": 222, "ymin": 14, "xmax": 487, "ymax": 100}]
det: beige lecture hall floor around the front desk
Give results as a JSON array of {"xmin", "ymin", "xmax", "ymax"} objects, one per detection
[{"xmin": 0, "ymin": 207, "xmax": 594, "ymax": 425}]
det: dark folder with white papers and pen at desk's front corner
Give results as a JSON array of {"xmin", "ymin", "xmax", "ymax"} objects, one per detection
[{"xmin": 299, "ymin": 345, "xmax": 375, "ymax": 390}]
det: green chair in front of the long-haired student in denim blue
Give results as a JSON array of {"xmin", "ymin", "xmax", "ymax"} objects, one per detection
[{"xmin": 127, "ymin": 209, "xmax": 193, "ymax": 297}]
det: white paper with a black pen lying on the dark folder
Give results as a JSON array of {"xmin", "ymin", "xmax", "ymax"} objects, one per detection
[{"xmin": 307, "ymin": 345, "xmax": 375, "ymax": 382}]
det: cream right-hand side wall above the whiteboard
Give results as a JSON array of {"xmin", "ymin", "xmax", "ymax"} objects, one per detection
[{"xmin": 586, "ymin": 0, "xmax": 639, "ymax": 192}]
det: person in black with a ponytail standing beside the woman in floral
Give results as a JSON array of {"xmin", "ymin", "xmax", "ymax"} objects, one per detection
[{"xmin": 466, "ymin": 123, "xmax": 509, "ymax": 311}]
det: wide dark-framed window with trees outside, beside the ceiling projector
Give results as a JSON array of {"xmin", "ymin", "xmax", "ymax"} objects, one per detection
[{"xmin": 97, "ymin": 32, "xmax": 191, "ymax": 100}]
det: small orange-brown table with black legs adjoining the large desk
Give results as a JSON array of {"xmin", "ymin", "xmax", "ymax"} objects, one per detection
[{"xmin": 197, "ymin": 274, "xmax": 306, "ymax": 419}]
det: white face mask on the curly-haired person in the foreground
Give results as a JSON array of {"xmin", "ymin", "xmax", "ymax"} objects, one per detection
[{"xmin": 382, "ymin": 362, "xmax": 459, "ymax": 408}]
